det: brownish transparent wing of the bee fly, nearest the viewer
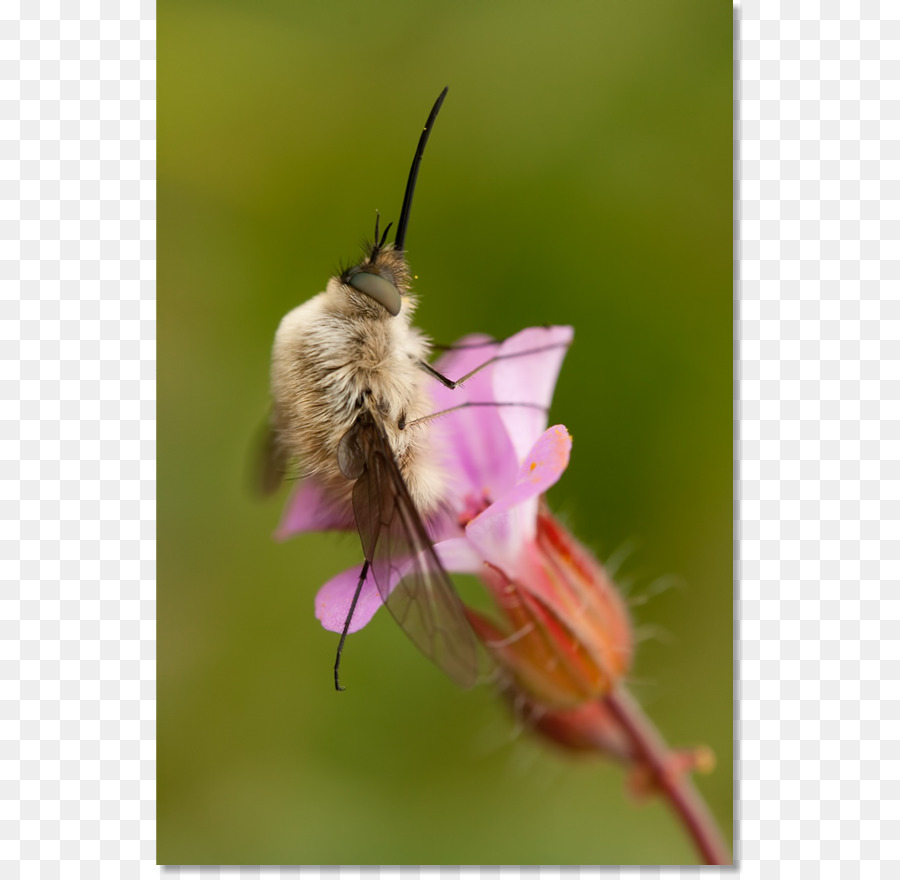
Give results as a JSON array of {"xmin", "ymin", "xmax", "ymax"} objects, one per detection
[{"xmin": 341, "ymin": 419, "xmax": 479, "ymax": 687}]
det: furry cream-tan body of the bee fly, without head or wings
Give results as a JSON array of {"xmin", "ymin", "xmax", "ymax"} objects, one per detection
[{"xmin": 272, "ymin": 279, "xmax": 443, "ymax": 514}]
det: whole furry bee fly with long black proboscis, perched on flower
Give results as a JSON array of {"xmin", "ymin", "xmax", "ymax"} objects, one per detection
[{"xmin": 263, "ymin": 88, "xmax": 548, "ymax": 690}]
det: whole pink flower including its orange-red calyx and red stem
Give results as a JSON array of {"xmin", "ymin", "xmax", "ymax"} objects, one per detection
[{"xmin": 278, "ymin": 327, "xmax": 730, "ymax": 864}]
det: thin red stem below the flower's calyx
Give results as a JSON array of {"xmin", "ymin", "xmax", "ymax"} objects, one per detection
[{"xmin": 604, "ymin": 687, "xmax": 732, "ymax": 865}]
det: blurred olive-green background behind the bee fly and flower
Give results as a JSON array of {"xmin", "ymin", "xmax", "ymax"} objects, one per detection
[{"xmin": 158, "ymin": 0, "xmax": 733, "ymax": 864}]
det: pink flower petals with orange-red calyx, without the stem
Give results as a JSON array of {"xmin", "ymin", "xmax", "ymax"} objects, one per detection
[{"xmin": 279, "ymin": 327, "xmax": 631, "ymax": 707}]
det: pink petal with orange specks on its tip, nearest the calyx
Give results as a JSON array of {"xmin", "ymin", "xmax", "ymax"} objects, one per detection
[{"xmin": 466, "ymin": 425, "xmax": 572, "ymax": 576}]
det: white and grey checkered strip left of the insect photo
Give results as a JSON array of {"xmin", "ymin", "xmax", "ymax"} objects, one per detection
[{"xmin": 0, "ymin": 2, "xmax": 158, "ymax": 877}]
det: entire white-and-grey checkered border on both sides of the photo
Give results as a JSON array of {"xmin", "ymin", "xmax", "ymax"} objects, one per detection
[{"xmin": 0, "ymin": 2, "xmax": 900, "ymax": 880}]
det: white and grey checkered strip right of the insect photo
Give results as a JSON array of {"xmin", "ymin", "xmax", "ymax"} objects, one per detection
[{"xmin": 738, "ymin": 3, "xmax": 900, "ymax": 878}]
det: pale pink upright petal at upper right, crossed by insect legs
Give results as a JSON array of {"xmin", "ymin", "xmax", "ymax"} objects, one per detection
[{"xmin": 493, "ymin": 327, "xmax": 573, "ymax": 461}]
